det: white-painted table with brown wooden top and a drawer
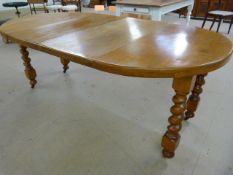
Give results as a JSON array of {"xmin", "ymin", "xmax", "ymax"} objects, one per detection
[{"xmin": 116, "ymin": 0, "xmax": 194, "ymax": 25}]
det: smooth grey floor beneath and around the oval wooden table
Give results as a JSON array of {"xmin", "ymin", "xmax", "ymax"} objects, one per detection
[{"xmin": 0, "ymin": 11, "xmax": 233, "ymax": 175}]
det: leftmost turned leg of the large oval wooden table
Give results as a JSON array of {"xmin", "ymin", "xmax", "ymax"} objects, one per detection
[{"xmin": 20, "ymin": 46, "xmax": 37, "ymax": 88}]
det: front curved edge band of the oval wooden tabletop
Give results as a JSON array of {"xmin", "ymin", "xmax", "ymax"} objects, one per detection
[{"xmin": 0, "ymin": 31, "xmax": 233, "ymax": 78}]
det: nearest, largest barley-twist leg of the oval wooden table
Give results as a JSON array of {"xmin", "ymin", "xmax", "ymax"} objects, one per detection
[{"xmin": 161, "ymin": 77, "xmax": 194, "ymax": 158}]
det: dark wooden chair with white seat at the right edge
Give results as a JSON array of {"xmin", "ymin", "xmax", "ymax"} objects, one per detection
[{"xmin": 202, "ymin": 0, "xmax": 233, "ymax": 34}]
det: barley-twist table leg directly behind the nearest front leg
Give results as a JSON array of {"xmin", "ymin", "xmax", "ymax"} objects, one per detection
[{"xmin": 184, "ymin": 74, "xmax": 207, "ymax": 120}]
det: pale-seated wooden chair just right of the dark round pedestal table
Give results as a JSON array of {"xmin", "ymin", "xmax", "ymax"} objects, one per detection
[{"xmin": 27, "ymin": 0, "xmax": 48, "ymax": 14}]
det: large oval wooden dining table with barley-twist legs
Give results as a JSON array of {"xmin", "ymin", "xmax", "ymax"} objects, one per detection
[{"xmin": 0, "ymin": 13, "xmax": 233, "ymax": 158}]
